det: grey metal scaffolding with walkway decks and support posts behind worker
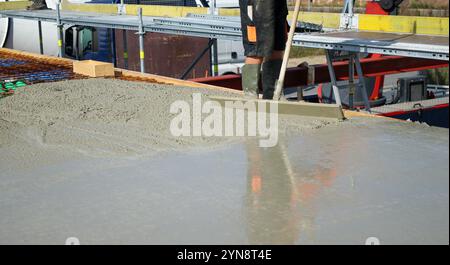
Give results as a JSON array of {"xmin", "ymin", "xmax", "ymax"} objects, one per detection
[{"xmin": 0, "ymin": 8, "xmax": 449, "ymax": 88}]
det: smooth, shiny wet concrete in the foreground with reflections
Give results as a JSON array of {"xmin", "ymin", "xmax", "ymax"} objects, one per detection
[{"xmin": 0, "ymin": 119, "xmax": 449, "ymax": 244}]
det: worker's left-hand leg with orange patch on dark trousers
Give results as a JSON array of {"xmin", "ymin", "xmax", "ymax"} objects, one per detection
[{"xmin": 239, "ymin": 0, "xmax": 264, "ymax": 98}]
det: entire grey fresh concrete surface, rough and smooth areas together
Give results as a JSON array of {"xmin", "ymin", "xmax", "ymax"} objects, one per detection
[{"xmin": 0, "ymin": 79, "xmax": 449, "ymax": 244}]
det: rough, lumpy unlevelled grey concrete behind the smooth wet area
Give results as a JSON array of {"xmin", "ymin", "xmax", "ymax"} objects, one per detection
[{"xmin": 0, "ymin": 79, "xmax": 340, "ymax": 158}]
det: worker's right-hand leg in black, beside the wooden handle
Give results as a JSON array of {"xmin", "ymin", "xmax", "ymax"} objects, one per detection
[{"xmin": 262, "ymin": 1, "xmax": 288, "ymax": 99}]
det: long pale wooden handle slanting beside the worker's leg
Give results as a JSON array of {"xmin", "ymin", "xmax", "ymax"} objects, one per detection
[{"xmin": 273, "ymin": 0, "xmax": 301, "ymax": 100}]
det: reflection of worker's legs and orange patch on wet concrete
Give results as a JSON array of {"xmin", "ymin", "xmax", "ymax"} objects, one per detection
[{"xmin": 247, "ymin": 138, "xmax": 336, "ymax": 244}]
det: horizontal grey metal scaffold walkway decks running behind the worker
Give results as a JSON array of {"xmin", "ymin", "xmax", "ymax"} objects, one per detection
[{"xmin": 0, "ymin": 10, "xmax": 449, "ymax": 61}]
